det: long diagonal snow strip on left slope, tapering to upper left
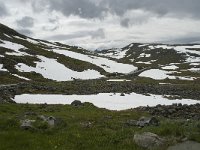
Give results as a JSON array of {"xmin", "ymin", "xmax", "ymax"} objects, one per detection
[{"xmin": 53, "ymin": 49, "xmax": 137, "ymax": 74}]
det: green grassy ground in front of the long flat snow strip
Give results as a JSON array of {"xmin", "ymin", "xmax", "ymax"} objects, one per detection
[{"xmin": 0, "ymin": 103, "xmax": 200, "ymax": 150}]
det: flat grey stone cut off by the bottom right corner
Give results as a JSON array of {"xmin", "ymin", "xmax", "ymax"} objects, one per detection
[{"xmin": 167, "ymin": 141, "xmax": 200, "ymax": 150}]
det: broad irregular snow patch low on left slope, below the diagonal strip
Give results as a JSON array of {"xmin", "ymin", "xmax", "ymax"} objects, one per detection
[{"xmin": 15, "ymin": 56, "xmax": 103, "ymax": 81}]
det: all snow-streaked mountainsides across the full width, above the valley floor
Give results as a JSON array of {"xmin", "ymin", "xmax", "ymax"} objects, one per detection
[{"xmin": 0, "ymin": 24, "xmax": 200, "ymax": 81}]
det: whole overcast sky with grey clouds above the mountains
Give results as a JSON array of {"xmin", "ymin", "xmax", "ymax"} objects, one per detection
[{"xmin": 0, "ymin": 0, "xmax": 200, "ymax": 49}]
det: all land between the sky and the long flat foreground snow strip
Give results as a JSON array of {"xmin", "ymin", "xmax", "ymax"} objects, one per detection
[{"xmin": 0, "ymin": 24, "xmax": 200, "ymax": 103}]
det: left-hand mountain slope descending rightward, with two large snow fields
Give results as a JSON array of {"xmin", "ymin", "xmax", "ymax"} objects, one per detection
[{"xmin": 0, "ymin": 24, "xmax": 137, "ymax": 81}]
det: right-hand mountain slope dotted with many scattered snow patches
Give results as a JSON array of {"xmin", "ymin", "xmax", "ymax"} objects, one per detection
[{"xmin": 98, "ymin": 43, "xmax": 200, "ymax": 80}]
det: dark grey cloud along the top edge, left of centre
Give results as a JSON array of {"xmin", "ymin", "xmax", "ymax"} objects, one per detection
[{"xmin": 32, "ymin": 0, "xmax": 106, "ymax": 19}]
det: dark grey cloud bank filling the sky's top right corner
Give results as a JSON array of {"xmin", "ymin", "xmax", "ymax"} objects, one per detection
[{"xmin": 101, "ymin": 0, "xmax": 200, "ymax": 17}]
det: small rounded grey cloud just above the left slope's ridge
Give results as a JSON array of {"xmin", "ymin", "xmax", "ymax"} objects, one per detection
[{"xmin": 16, "ymin": 16, "xmax": 34, "ymax": 28}]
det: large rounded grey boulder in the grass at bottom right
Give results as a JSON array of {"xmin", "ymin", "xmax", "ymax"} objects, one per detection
[{"xmin": 134, "ymin": 132, "xmax": 165, "ymax": 149}]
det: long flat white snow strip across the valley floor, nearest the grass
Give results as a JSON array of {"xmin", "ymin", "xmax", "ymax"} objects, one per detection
[{"xmin": 13, "ymin": 93, "xmax": 200, "ymax": 110}]
